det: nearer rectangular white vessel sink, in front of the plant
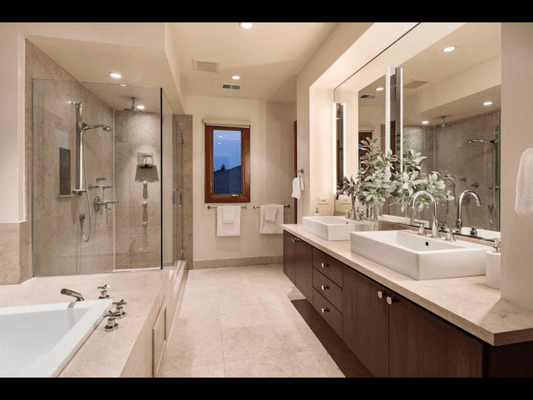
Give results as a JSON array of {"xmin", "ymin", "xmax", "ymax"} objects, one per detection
[{"xmin": 350, "ymin": 230, "xmax": 491, "ymax": 280}]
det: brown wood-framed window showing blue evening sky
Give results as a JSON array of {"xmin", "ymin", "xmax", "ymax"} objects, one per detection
[{"xmin": 205, "ymin": 124, "xmax": 250, "ymax": 203}]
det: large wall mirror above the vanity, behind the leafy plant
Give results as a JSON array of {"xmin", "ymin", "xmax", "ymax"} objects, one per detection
[{"xmin": 335, "ymin": 23, "xmax": 501, "ymax": 239}]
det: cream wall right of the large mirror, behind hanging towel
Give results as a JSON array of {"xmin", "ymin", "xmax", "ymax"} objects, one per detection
[{"xmin": 500, "ymin": 23, "xmax": 533, "ymax": 309}]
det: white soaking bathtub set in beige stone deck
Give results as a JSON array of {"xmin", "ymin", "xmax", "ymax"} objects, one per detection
[{"xmin": 0, "ymin": 299, "xmax": 113, "ymax": 377}]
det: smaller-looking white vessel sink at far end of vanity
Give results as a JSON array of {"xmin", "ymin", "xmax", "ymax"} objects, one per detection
[{"xmin": 302, "ymin": 216, "xmax": 374, "ymax": 240}]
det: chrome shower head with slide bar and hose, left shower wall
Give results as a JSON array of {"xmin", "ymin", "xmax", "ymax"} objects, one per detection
[{"xmin": 73, "ymin": 103, "xmax": 113, "ymax": 242}]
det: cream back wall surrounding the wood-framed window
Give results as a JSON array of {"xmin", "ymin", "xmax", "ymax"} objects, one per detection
[{"xmin": 184, "ymin": 96, "xmax": 296, "ymax": 261}]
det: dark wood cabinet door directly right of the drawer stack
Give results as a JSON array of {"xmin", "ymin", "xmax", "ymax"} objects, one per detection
[{"xmin": 342, "ymin": 267, "xmax": 389, "ymax": 377}]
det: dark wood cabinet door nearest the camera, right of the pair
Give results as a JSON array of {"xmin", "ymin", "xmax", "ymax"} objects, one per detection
[{"xmin": 387, "ymin": 294, "xmax": 483, "ymax": 377}]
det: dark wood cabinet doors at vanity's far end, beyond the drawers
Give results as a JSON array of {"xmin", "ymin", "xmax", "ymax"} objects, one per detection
[{"xmin": 283, "ymin": 232, "xmax": 313, "ymax": 302}]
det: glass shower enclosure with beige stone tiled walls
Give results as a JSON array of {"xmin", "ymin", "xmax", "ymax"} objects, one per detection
[{"xmin": 31, "ymin": 79, "xmax": 183, "ymax": 276}]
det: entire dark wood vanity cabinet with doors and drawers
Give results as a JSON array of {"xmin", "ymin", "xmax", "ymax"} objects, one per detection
[{"xmin": 283, "ymin": 231, "xmax": 533, "ymax": 377}]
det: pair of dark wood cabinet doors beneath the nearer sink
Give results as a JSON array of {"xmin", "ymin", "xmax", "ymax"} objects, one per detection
[{"xmin": 343, "ymin": 267, "xmax": 484, "ymax": 377}]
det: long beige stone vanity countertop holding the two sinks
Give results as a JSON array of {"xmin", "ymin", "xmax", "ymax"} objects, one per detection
[{"xmin": 283, "ymin": 224, "xmax": 533, "ymax": 346}]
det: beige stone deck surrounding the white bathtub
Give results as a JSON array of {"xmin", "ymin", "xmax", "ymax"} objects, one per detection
[{"xmin": 0, "ymin": 269, "xmax": 172, "ymax": 377}]
